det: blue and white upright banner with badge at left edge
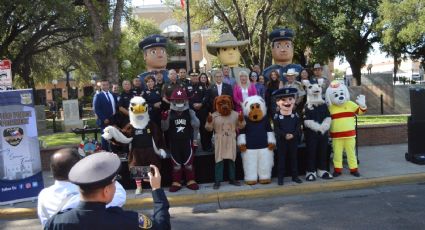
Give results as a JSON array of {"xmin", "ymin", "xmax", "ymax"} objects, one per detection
[{"xmin": 0, "ymin": 90, "xmax": 44, "ymax": 205}]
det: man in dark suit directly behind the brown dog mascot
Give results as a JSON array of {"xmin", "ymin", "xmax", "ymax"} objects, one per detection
[{"xmin": 206, "ymin": 70, "xmax": 233, "ymax": 112}]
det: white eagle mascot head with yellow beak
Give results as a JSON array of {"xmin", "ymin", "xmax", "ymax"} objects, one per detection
[{"xmin": 128, "ymin": 96, "xmax": 149, "ymax": 129}]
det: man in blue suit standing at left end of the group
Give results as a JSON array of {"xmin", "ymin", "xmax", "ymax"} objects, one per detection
[{"xmin": 94, "ymin": 80, "xmax": 117, "ymax": 151}]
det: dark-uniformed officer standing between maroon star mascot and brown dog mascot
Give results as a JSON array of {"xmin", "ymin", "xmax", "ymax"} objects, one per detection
[{"xmin": 187, "ymin": 71, "xmax": 212, "ymax": 151}]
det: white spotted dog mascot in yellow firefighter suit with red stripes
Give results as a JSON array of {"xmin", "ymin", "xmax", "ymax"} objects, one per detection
[{"xmin": 326, "ymin": 81, "xmax": 367, "ymax": 177}]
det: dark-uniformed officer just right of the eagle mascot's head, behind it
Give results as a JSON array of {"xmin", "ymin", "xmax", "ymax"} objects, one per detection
[{"xmin": 142, "ymin": 76, "xmax": 162, "ymax": 127}]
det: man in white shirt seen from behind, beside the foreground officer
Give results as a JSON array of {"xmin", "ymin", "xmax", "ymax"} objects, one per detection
[{"xmin": 37, "ymin": 148, "xmax": 126, "ymax": 226}]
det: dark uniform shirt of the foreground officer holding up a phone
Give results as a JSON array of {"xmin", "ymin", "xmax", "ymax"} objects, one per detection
[{"xmin": 44, "ymin": 189, "xmax": 171, "ymax": 230}]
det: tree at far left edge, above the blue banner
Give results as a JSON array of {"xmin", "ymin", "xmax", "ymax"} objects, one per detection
[{"xmin": 0, "ymin": 0, "xmax": 87, "ymax": 88}]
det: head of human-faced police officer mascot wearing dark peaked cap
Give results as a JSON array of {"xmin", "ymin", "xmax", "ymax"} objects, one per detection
[{"xmin": 272, "ymin": 87, "xmax": 298, "ymax": 115}]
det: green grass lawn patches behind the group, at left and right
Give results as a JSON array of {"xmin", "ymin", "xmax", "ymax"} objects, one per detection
[{"xmin": 39, "ymin": 115, "xmax": 408, "ymax": 147}]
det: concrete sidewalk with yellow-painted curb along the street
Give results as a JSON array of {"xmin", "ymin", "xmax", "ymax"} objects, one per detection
[{"xmin": 0, "ymin": 144, "xmax": 425, "ymax": 219}]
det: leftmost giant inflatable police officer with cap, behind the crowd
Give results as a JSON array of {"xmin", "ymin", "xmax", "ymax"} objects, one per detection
[{"xmin": 139, "ymin": 34, "xmax": 168, "ymax": 84}]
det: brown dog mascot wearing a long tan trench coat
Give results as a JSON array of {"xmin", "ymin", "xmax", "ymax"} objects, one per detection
[{"xmin": 205, "ymin": 95, "xmax": 245, "ymax": 189}]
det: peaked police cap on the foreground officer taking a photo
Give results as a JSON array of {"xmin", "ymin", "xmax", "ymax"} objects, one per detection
[{"xmin": 68, "ymin": 152, "xmax": 121, "ymax": 189}]
